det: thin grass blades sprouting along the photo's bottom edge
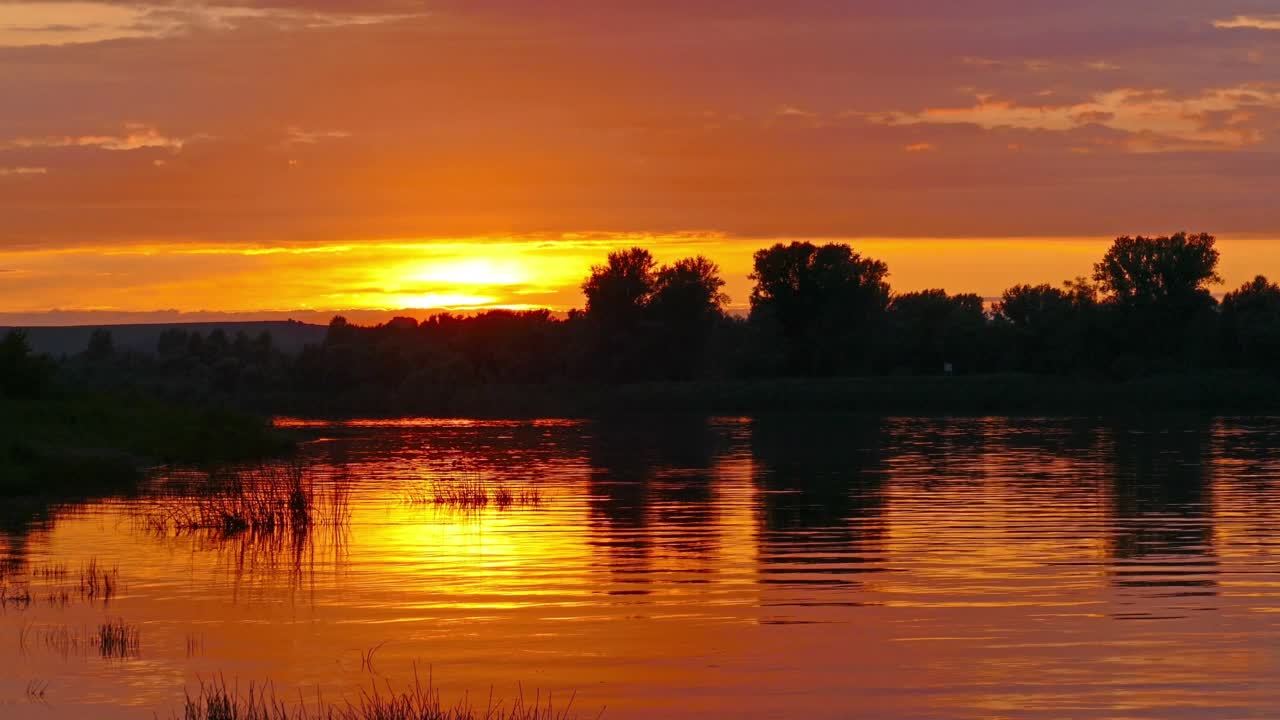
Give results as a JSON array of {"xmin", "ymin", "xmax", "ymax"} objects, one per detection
[{"xmin": 173, "ymin": 671, "xmax": 591, "ymax": 720}]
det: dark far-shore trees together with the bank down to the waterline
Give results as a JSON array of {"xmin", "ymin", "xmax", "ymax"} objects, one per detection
[{"xmin": 20, "ymin": 233, "xmax": 1280, "ymax": 415}]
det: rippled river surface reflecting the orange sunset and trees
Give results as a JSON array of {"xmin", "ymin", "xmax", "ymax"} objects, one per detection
[{"xmin": 0, "ymin": 416, "xmax": 1280, "ymax": 719}]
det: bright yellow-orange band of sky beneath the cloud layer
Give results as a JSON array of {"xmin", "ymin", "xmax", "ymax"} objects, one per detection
[{"xmin": 0, "ymin": 234, "xmax": 1280, "ymax": 324}]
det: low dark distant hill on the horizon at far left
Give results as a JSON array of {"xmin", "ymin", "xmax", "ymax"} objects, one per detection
[{"xmin": 0, "ymin": 320, "xmax": 325, "ymax": 357}]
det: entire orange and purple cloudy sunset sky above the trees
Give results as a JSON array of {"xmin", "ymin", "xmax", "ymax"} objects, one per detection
[{"xmin": 0, "ymin": 0, "xmax": 1280, "ymax": 324}]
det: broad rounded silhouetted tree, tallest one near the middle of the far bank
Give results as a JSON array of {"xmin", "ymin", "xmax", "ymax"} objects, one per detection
[{"xmin": 750, "ymin": 242, "xmax": 890, "ymax": 374}]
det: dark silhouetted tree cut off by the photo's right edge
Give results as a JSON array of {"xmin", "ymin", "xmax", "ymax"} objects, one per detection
[{"xmin": 1222, "ymin": 275, "xmax": 1280, "ymax": 370}]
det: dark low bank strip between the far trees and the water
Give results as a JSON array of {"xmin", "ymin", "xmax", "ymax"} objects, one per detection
[{"xmin": 264, "ymin": 373, "xmax": 1280, "ymax": 419}]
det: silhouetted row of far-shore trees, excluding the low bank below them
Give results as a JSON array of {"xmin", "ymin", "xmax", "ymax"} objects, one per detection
[{"xmin": 17, "ymin": 233, "xmax": 1280, "ymax": 404}]
